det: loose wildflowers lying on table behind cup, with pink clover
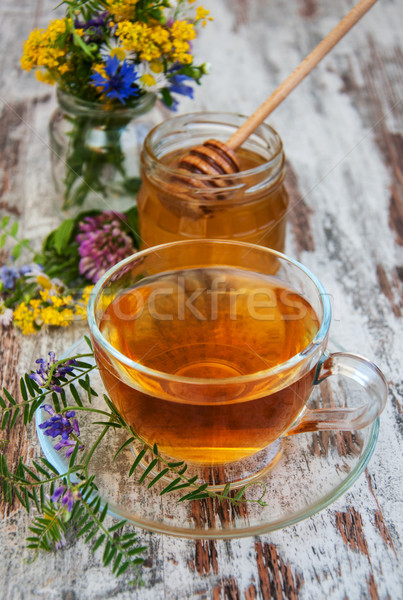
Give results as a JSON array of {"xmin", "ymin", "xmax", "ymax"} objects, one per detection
[{"xmin": 0, "ymin": 208, "xmax": 137, "ymax": 335}]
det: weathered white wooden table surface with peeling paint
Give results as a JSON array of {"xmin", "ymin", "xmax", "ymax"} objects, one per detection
[{"xmin": 0, "ymin": 0, "xmax": 403, "ymax": 600}]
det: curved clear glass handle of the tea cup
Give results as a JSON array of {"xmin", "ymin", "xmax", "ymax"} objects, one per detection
[{"xmin": 285, "ymin": 352, "xmax": 388, "ymax": 435}]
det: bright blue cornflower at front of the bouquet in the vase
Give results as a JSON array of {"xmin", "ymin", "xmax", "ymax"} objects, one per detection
[{"xmin": 91, "ymin": 56, "xmax": 139, "ymax": 104}]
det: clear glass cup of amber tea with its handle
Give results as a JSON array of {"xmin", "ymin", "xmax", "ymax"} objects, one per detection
[{"xmin": 88, "ymin": 240, "xmax": 387, "ymax": 487}]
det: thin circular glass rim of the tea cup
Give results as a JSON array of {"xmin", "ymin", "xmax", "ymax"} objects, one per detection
[{"xmin": 87, "ymin": 239, "xmax": 331, "ymax": 385}]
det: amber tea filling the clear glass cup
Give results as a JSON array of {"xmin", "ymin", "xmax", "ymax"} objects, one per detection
[{"xmin": 95, "ymin": 266, "xmax": 319, "ymax": 464}]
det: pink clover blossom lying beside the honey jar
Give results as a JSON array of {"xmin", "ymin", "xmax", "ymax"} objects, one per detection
[{"xmin": 76, "ymin": 211, "xmax": 136, "ymax": 283}]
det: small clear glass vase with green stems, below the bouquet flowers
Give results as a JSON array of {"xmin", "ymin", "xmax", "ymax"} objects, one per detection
[{"xmin": 49, "ymin": 89, "xmax": 162, "ymax": 218}]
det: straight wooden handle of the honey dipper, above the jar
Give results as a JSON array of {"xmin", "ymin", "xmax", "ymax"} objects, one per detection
[{"xmin": 227, "ymin": 0, "xmax": 377, "ymax": 150}]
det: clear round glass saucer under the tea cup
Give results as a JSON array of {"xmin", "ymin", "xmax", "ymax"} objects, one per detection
[{"xmin": 36, "ymin": 339, "xmax": 379, "ymax": 539}]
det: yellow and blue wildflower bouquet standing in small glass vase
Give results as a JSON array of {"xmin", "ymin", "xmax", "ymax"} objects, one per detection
[{"xmin": 21, "ymin": 0, "xmax": 210, "ymax": 210}]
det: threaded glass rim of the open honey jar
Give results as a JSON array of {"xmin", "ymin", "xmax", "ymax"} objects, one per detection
[{"xmin": 142, "ymin": 111, "xmax": 284, "ymax": 183}]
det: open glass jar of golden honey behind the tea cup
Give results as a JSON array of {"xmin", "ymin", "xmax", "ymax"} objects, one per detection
[{"xmin": 137, "ymin": 112, "xmax": 288, "ymax": 252}]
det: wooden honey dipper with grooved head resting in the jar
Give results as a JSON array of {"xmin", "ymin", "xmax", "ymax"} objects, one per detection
[{"xmin": 175, "ymin": 0, "xmax": 377, "ymax": 185}]
